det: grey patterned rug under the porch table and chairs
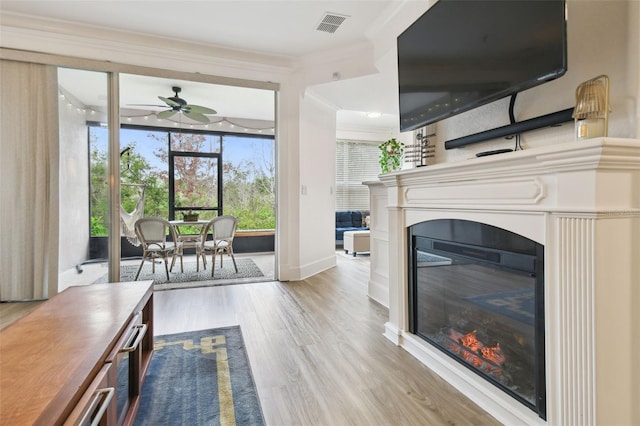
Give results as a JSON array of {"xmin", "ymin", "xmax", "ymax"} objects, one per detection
[{"xmin": 96, "ymin": 258, "xmax": 273, "ymax": 291}]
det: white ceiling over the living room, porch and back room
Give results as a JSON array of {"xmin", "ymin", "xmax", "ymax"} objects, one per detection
[{"xmin": 0, "ymin": 0, "xmax": 402, "ymax": 128}]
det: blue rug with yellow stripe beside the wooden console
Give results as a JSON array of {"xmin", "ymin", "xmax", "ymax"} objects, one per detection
[{"xmin": 135, "ymin": 326, "xmax": 264, "ymax": 426}]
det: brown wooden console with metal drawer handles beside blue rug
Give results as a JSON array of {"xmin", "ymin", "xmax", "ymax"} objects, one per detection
[{"xmin": 0, "ymin": 281, "xmax": 153, "ymax": 425}]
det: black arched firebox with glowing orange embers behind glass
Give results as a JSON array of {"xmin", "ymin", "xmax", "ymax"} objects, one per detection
[{"xmin": 408, "ymin": 219, "xmax": 546, "ymax": 419}]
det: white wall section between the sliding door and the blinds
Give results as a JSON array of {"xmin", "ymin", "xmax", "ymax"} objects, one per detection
[{"xmin": 276, "ymin": 74, "xmax": 336, "ymax": 281}]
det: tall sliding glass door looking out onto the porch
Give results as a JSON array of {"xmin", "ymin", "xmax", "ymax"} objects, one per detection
[{"xmin": 59, "ymin": 68, "xmax": 275, "ymax": 288}]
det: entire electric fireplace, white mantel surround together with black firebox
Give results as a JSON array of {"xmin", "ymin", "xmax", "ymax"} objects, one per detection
[{"xmin": 369, "ymin": 136, "xmax": 640, "ymax": 426}]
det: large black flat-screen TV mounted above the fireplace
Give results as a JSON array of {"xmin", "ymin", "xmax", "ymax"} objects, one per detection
[{"xmin": 397, "ymin": 0, "xmax": 567, "ymax": 132}]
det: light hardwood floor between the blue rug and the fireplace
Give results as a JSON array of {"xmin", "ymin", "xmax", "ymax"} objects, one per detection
[{"xmin": 154, "ymin": 253, "xmax": 499, "ymax": 425}]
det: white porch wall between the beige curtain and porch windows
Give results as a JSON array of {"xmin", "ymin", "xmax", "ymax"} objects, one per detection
[{"xmin": 58, "ymin": 94, "xmax": 89, "ymax": 272}]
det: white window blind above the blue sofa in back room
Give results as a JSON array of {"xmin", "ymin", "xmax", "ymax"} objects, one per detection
[{"xmin": 336, "ymin": 139, "xmax": 381, "ymax": 210}]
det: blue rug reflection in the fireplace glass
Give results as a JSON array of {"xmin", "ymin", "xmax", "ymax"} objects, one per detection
[{"xmin": 466, "ymin": 289, "xmax": 536, "ymax": 325}]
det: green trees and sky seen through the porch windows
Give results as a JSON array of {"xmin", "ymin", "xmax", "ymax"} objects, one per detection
[{"xmin": 90, "ymin": 130, "xmax": 275, "ymax": 236}]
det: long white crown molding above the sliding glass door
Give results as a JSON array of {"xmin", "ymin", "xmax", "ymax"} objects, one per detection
[{"xmin": 0, "ymin": 13, "xmax": 294, "ymax": 82}]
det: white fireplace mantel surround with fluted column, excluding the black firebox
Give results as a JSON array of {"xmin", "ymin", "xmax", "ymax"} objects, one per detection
[{"xmin": 372, "ymin": 138, "xmax": 640, "ymax": 426}]
